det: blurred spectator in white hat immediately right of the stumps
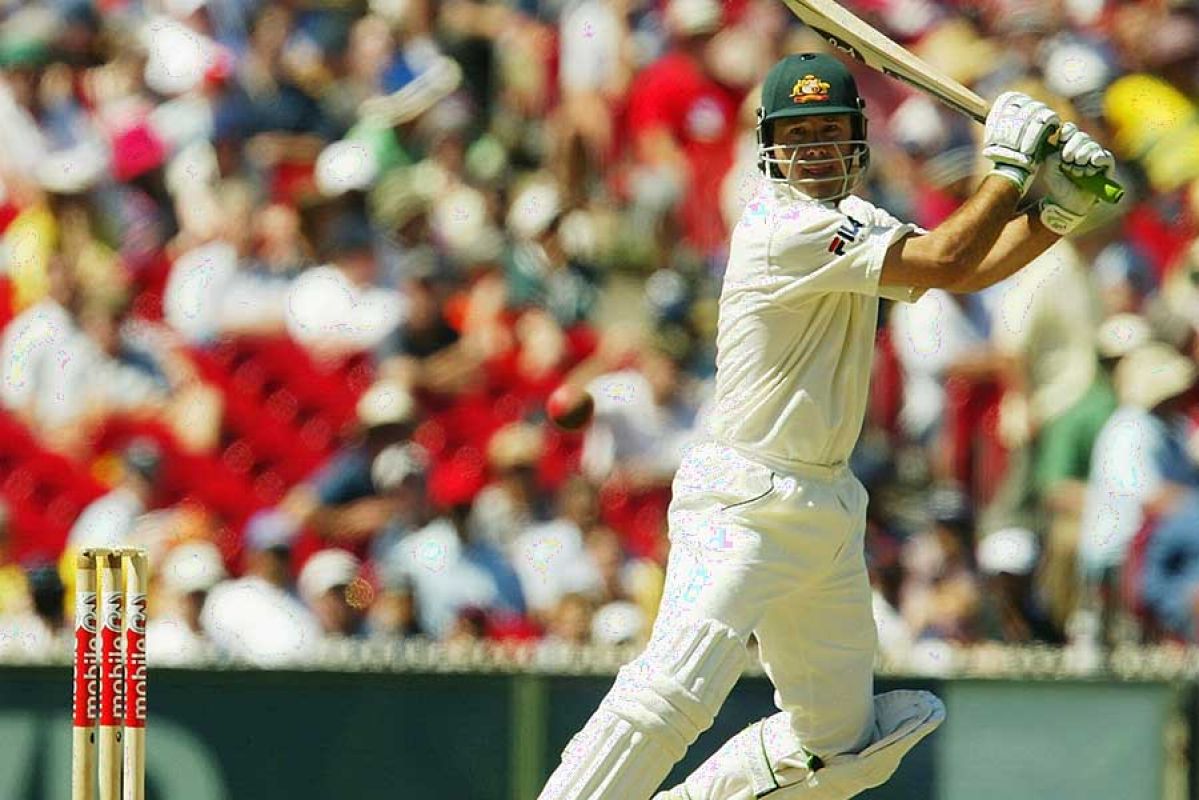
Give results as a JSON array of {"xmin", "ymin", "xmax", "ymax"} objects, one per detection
[{"xmin": 146, "ymin": 540, "xmax": 227, "ymax": 664}]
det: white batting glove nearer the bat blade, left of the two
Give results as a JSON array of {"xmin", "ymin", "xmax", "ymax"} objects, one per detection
[{"xmin": 982, "ymin": 91, "xmax": 1061, "ymax": 197}]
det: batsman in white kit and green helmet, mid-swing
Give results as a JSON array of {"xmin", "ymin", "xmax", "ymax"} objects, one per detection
[{"xmin": 541, "ymin": 54, "xmax": 1114, "ymax": 800}]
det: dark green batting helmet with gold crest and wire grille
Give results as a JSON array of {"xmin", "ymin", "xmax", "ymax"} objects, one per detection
[{"xmin": 758, "ymin": 53, "xmax": 870, "ymax": 200}]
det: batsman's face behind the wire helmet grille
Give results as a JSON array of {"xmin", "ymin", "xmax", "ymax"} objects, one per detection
[{"xmin": 773, "ymin": 114, "xmax": 854, "ymax": 198}]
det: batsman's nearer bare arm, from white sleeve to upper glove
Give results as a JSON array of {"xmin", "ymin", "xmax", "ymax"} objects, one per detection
[{"xmin": 880, "ymin": 175, "xmax": 1020, "ymax": 289}]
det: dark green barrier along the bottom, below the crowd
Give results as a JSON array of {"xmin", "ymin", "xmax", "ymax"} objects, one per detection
[{"xmin": 0, "ymin": 666, "xmax": 1197, "ymax": 800}]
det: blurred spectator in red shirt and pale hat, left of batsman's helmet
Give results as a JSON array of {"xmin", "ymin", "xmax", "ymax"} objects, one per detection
[{"xmin": 628, "ymin": 0, "xmax": 741, "ymax": 255}]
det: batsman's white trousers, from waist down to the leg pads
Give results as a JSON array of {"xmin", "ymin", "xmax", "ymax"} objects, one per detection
[{"xmin": 671, "ymin": 443, "xmax": 878, "ymax": 758}]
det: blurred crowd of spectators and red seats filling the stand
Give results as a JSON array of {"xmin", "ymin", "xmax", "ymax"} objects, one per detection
[{"xmin": 0, "ymin": 0, "xmax": 1199, "ymax": 664}]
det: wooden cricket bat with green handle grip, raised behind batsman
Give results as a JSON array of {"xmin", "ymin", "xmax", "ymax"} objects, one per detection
[{"xmin": 783, "ymin": 0, "xmax": 1123, "ymax": 203}]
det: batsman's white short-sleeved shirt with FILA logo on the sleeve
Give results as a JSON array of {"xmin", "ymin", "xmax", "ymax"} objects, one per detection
[{"xmin": 709, "ymin": 179, "xmax": 921, "ymax": 471}]
